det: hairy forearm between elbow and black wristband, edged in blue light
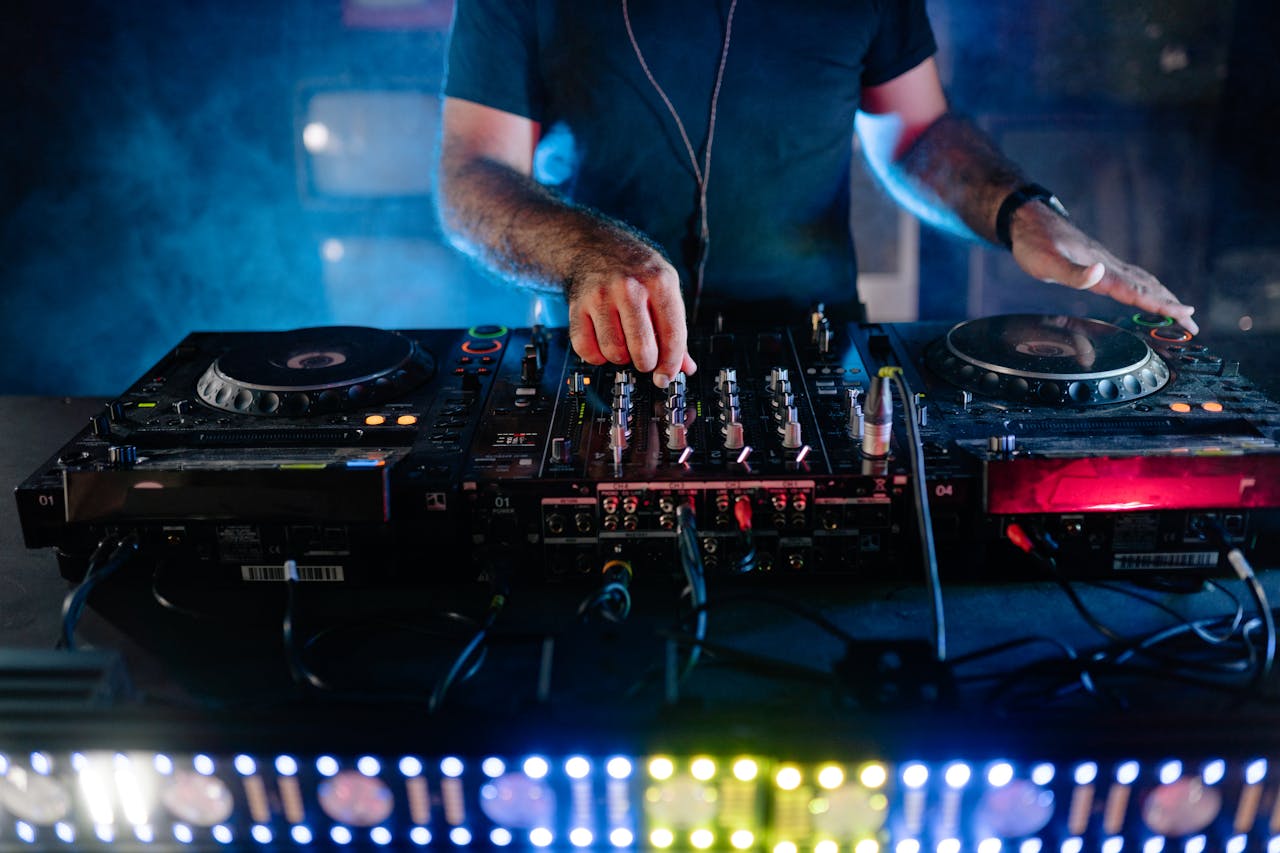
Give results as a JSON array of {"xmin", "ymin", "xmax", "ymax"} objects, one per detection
[{"xmin": 864, "ymin": 113, "xmax": 1025, "ymax": 242}]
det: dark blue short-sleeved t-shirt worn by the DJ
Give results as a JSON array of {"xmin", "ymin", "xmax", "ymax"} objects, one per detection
[{"xmin": 444, "ymin": 0, "xmax": 934, "ymax": 316}]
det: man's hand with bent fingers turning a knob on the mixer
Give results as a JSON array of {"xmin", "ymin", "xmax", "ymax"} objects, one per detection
[{"xmin": 566, "ymin": 243, "xmax": 698, "ymax": 388}]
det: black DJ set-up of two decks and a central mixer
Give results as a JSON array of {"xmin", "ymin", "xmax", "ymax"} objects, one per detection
[{"xmin": 17, "ymin": 309, "xmax": 1280, "ymax": 584}]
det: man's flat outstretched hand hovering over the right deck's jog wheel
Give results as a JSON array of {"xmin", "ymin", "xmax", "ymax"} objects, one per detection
[{"xmin": 1009, "ymin": 201, "xmax": 1199, "ymax": 334}]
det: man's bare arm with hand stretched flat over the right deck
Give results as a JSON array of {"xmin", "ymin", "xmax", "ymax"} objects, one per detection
[{"xmin": 858, "ymin": 59, "xmax": 1199, "ymax": 334}]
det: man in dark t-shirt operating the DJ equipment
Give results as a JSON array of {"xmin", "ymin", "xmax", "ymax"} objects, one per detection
[{"xmin": 440, "ymin": 0, "xmax": 1198, "ymax": 387}]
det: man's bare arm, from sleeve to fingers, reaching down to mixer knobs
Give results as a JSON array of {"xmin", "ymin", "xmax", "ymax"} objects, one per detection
[{"xmin": 439, "ymin": 97, "xmax": 698, "ymax": 387}]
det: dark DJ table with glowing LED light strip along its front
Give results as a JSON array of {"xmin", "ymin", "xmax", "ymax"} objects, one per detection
[{"xmin": 0, "ymin": 324, "xmax": 1280, "ymax": 853}]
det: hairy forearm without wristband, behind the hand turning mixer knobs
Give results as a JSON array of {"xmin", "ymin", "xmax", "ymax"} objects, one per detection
[{"xmin": 440, "ymin": 154, "xmax": 660, "ymax": 293}]
